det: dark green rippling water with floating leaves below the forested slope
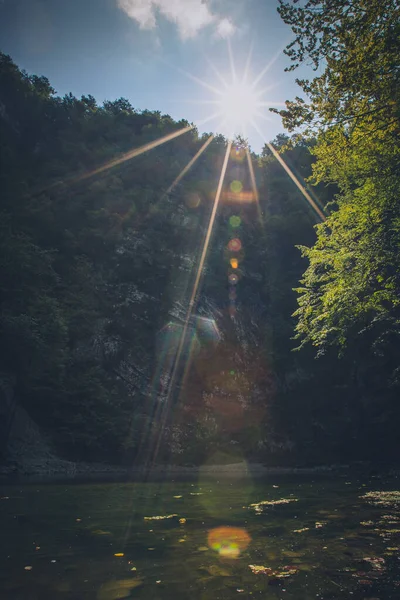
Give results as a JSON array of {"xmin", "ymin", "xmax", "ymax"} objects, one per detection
[{"xmin": 0, "ymin": 474, "xmax": 400, "ymax": 600}]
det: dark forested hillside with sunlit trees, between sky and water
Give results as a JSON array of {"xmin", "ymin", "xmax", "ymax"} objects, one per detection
[{"xmin": 0, "ymin": 0, "xmax": 400, "ymax": 466}]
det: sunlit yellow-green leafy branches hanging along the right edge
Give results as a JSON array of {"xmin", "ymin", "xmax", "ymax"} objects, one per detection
[{"xmin": 279, "ymin": 0, "xmax": 400, "ymax": 370}]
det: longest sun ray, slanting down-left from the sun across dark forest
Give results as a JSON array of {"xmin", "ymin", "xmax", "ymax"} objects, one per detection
[{"xmin": 153, "ymin": 141, "xmax": 232, "ymax": 461}]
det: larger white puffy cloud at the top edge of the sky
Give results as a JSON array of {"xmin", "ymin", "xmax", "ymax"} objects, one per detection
[{"xmin": 117, "ymin": 0, "xmax": 236, "ymax": 40}]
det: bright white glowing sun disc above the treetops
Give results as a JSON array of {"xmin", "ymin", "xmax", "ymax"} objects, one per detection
[{"xmin": 217, "ymin": 81, "xmax": 261, "ymax": 137}]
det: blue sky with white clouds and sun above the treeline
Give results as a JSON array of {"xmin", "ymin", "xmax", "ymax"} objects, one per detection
[{"xmin": 0, "ymin": 0, "xmax": 312, "ymax": 152}]
